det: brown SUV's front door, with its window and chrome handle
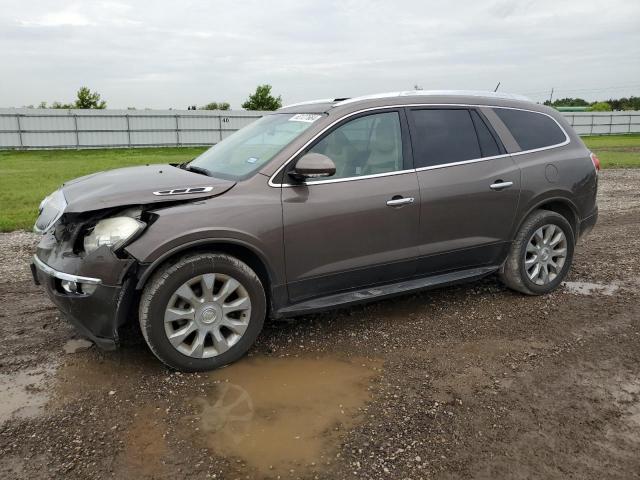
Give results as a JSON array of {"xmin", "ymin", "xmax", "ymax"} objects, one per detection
[{"xmin": 282, "ymin": 110, "xmax": 420, "ymax": 302}]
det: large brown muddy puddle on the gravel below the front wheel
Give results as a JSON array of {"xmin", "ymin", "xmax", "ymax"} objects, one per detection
[{"xmin": 194, "ymin": 358, "xmax": 381, "ymax": 476}]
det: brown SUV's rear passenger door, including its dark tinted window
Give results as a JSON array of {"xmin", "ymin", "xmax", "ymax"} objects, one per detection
[{"xmin": 408, "ymin": 106, "xmax": 520, "ymax": 274}]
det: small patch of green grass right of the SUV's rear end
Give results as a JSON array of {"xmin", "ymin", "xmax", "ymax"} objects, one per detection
[{"xmin": 582, "ymin": 134, "xmax": 640, "ymax": 168}]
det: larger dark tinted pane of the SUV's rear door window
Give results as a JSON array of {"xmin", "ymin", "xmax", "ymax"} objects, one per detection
[{"xmin": 409, "ymin": 108, "xmax": 482, "ymax": 168}]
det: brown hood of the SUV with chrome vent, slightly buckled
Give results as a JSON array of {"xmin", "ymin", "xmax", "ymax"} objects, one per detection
[{"xmin": 62, "ymin": 165, "xmax": 235, "ymax": 213}]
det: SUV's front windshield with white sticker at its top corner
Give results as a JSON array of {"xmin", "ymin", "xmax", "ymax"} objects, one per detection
[{"xmin": 187, "ymin": 113, "xmax": 322, "ymax": 180}]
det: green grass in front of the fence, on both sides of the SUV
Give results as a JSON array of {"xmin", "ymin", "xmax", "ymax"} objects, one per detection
[{"xmin": 0, "ymin": 134, "xmax": 640, "ymax": 232}]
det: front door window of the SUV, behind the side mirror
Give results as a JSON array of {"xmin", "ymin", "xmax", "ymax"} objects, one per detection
[{"xmin": 308, "ymin": 112, "xmax": 403, "ymax": 179}]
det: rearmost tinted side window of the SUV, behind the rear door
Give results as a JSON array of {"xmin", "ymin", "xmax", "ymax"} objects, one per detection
[{"xmin": 493, "ymin": 108, "xmax": 566, "ymax": 150}]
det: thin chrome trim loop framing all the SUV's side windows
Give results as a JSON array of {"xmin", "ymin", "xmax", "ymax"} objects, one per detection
[{"xmin": 268, "ymin": 103, "xmax": 571, "ymax": 188}]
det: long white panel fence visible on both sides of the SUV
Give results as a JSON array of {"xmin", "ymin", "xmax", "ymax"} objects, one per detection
[{"xmin": 0, "ymin": 108, "xmax": 640, "ymax": 149}]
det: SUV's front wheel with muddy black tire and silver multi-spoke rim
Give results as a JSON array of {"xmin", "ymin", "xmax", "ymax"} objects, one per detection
[{"xmin": 139, "ymin": 253, "xmax": 267, "ymax": 372}]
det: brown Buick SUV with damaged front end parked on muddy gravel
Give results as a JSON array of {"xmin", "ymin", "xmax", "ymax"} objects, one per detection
[{"xmin": 32, "ymin": 91, "xmax": 599, "ymax": 371}]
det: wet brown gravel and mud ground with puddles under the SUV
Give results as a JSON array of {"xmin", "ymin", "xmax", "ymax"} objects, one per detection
[{"xmin": 0, "ymin": 170, "xmax": 640, "ymax": 479}]
